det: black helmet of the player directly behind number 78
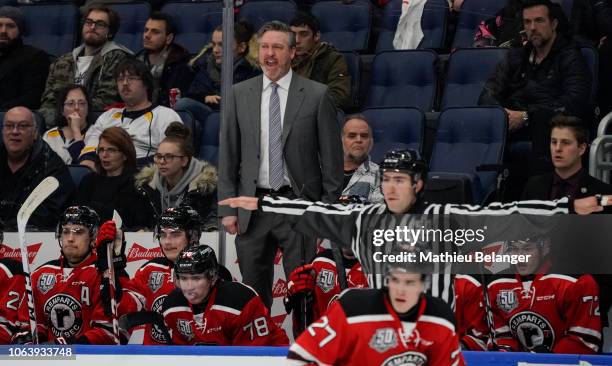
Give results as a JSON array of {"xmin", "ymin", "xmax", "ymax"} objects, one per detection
[{"xmin": 155, "ymin": 205, "xmax": 202, "ymax": 246}]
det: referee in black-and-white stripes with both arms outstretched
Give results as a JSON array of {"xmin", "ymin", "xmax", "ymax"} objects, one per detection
[{"xmin": 219, "ymin": 150, "xmax": 612, "ymax": 303}]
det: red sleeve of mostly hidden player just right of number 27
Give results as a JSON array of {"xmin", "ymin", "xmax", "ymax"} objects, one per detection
[{"xmin": 455, "ymin": 274, "xmax": 490, "ymax": 351}]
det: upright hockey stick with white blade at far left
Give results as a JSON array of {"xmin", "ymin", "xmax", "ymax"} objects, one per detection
[{"xmin": 17, "ymin": 177, "xmax": 59, "ymax": 344}]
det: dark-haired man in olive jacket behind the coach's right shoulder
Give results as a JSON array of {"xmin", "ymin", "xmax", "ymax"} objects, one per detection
[{"xmin": 290, "ymin": 12, "xmax": 351, "ymax": 110}]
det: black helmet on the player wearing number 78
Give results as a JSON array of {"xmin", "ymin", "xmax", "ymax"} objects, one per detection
[{"xmin": 174, "ymin": 244, "xmax": 219, "ymax": 280}]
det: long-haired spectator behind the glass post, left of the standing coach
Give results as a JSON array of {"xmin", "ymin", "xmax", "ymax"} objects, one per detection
[{"xmin": 176, "ymin": 21, "xmax": 260, "ymax": 126}]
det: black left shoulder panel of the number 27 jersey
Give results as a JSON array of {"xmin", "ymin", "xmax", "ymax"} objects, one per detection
[{"xmin": 338, "ymin": 288, "xmax": 388, "ymax": 318}]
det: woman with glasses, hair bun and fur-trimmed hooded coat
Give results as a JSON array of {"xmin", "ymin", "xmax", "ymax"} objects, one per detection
[{"xmin": 136, "ymin": 122, "xmax": 217, "ymax": 230}]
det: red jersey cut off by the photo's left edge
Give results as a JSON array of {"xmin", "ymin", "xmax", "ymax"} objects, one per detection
[{"xmin": 0, "ymin": 258, "xmax": 27, "ymax": 344}]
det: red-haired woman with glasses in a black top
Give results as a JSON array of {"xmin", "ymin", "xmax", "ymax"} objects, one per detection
[{"xmin": 75, "ymin": 127, "xmax": 153, "ymax": 231}]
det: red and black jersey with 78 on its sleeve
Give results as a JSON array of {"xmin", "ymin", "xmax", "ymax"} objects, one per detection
[{"xmin": 162, "ymin": 281, "xmax": 289, "ymax": 346}]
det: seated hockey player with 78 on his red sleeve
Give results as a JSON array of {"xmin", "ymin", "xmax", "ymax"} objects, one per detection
[{"xmin": 162, "ymin": 245, "xmax": 289, "ymax": 346}]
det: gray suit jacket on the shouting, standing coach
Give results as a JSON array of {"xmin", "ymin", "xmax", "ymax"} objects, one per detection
[{"xmin": 218, "ymin": 73, "xmax": 343, "ymax": 233}]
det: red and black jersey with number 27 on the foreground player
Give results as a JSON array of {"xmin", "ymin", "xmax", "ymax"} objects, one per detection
[{"xmin": 287, "ymin": 289, "xmax": 464, "ymax": 366}]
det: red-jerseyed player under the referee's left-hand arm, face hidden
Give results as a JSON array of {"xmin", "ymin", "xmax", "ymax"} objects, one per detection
[{"xmin": 284, "ymin": 248, "xmax": 368, "ymax": 337}]
